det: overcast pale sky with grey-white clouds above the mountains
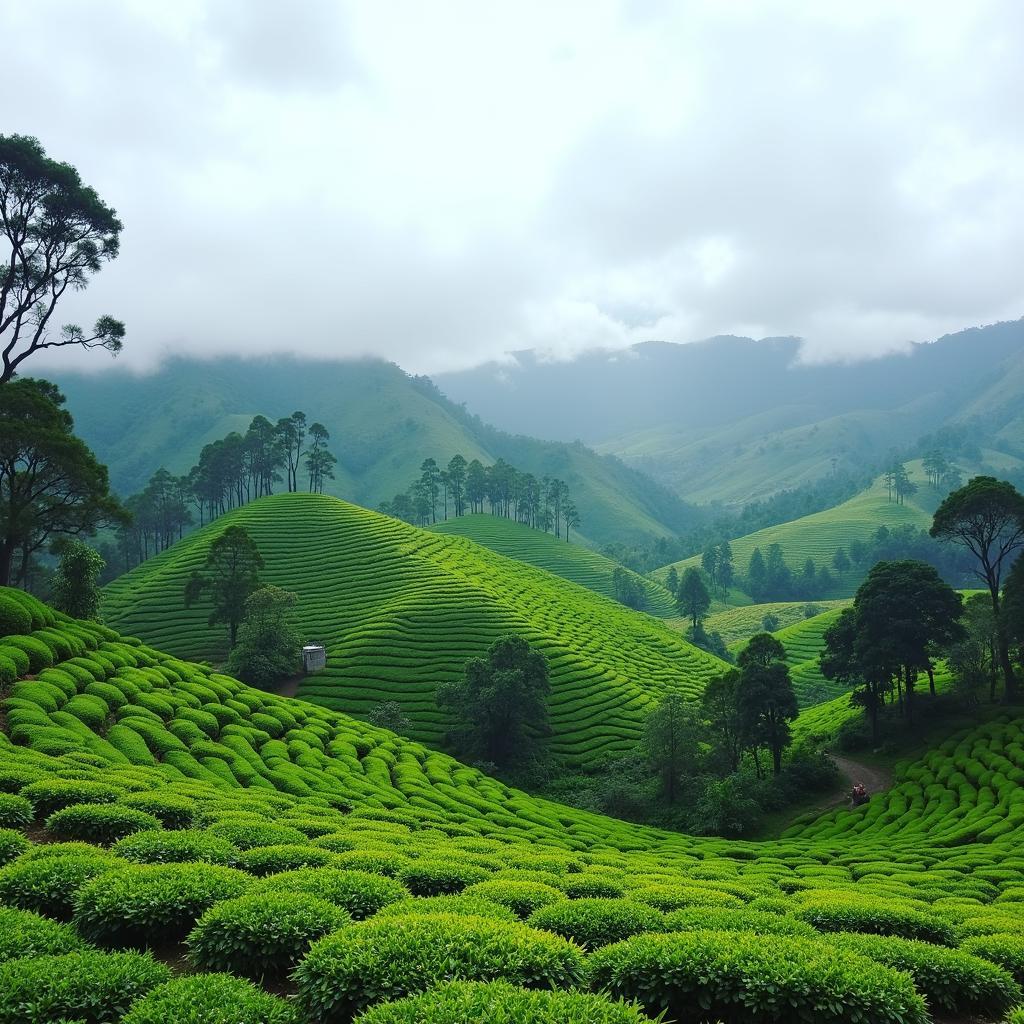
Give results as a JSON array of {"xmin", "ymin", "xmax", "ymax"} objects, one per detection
[{"xmin": 8, "ymin": 0, "xmax": 1024, "ymax": 373}]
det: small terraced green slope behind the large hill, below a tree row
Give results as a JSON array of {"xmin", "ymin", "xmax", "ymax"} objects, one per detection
[{"xmin": 430, "ymin": 514, "xmax": 678, "ymax": 618}]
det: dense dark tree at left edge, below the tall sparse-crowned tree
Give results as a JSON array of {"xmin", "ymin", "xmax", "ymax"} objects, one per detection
[{"xmin": 0, "ymin": 377, "xmax": 127, "ymax": 586}]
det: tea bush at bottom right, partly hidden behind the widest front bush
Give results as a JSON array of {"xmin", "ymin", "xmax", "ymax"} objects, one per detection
[{"xmin": 834, "ymin": 934, "xmax": 1022, "ymax": 1017}]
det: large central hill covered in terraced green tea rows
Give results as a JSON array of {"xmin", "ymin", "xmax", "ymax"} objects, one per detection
[{"xmin": 103, "ymin": 494, "xmax": 721, "ymax": 764}]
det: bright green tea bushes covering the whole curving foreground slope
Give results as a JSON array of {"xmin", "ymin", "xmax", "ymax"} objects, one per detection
[{"xmin": 0, "ymin": 591, "xmax": 1024, "ymax": 1024}]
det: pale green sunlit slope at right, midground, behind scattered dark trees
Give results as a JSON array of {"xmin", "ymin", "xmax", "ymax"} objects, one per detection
[{"xmin": 654, "ymin": 463, "xmax": 931, "ymax": 597}]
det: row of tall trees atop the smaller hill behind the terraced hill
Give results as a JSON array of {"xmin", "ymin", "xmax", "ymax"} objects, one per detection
[{"xmin": 380, "ymin": 455, "xmax": 580, "ymax": 541}]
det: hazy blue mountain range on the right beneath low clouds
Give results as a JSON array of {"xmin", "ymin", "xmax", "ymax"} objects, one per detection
[{"xmin": 436, "ymin": 319, "xmax": 1024, "ymax": 504}]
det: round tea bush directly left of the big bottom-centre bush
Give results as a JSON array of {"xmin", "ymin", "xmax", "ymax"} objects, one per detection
[{"xmin": 188, "ymin": 893, "xmax": 351, "ymax": 978}]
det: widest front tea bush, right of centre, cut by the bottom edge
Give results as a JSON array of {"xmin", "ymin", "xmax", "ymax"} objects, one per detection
[{"xmin": 590, "ymin": 932, "xmax": 928, "ymax": 1024}]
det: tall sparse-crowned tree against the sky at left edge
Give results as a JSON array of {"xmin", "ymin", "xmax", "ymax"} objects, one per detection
[{"xmin": 0, "ymin": 135, "xmax": 125, "ymax": 384}]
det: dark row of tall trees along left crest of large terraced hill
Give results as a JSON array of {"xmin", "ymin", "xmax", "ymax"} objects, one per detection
[{"xmin": 110, "ymin": 412, "xmax": 337, "ymax": 577}]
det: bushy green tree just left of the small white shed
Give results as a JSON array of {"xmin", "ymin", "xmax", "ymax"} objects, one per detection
[{"xmin": 227, "ymin": 586, "xmax": 302, "ymax": 688}]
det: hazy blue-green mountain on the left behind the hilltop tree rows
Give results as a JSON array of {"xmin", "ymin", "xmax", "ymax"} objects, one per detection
[{"xmin": 51, "ymin": 357, "xmax": 700, "ymax": 544}]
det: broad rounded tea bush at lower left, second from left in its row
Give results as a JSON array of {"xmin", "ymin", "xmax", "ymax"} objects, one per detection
[{"xmin": 75, "ymin": 864, "xmax": 251, "ymax": 945}]
